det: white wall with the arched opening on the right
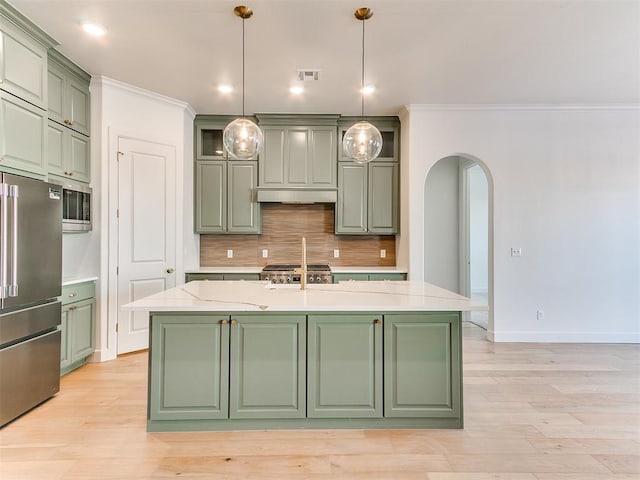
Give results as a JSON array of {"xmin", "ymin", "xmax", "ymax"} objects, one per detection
[{"xmin": 399, "ymin": 105, "xmax": 640, "ymax": 342}]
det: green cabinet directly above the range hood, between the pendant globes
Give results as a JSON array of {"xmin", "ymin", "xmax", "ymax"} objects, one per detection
[{"xmin": 257, "ymin": 114, "xmax": 338, "ymax": 194}]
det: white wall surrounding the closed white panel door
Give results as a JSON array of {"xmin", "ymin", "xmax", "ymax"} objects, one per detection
[{"xmin": 91, "ymin": 77, "xmax": 197, "ymax": 361}]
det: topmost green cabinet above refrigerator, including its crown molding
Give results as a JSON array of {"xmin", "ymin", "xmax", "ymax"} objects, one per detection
[{"xmin": 0, "ymin": 2, "xmax": 56, "ymax": 110}]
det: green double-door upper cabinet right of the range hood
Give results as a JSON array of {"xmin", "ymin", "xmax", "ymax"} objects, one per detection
[{"xmin": 335, "ymin": 162, "xmax": 399, "ymax": 235}]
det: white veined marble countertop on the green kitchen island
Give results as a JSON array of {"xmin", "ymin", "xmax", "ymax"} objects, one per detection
[{"xmin": 123, "ymin": 280, "xmax": 486, "ymax": 313}]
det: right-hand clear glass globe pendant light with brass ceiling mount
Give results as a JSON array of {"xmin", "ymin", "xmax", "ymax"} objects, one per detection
[{"xmin": 342, "ymin": 7, "xmax": 382, "ymax": 163}]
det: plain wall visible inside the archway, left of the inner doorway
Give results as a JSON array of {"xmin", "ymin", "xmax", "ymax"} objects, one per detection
[{"xmin": 424, "ymin": 157, "xmax": 460, "ymax": 292}]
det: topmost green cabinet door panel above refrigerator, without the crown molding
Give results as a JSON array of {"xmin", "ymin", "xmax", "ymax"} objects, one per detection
[{"xmin": 0, "ymin": 22, "xmax": 47, "ymax": 109}]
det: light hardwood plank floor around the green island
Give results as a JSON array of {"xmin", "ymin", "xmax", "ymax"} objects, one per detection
[{"xmin": 0, "ymin": 323, "xmax": 640, "ymax": 480}]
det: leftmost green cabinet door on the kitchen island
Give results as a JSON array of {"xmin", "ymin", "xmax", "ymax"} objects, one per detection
[{"xmin": 149, "ymin": 314, "xmax": 229, "ymax": 420}]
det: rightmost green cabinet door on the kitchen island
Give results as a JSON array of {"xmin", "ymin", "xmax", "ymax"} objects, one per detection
[{"xmin": 384, "ymin": 312, "xmax": 462, "ymax": 417}]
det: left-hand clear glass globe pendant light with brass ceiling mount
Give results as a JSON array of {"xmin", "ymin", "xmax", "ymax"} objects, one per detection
[{"xmin": 222, "ymin": 5, "xmax": 264, "ymax": 160}]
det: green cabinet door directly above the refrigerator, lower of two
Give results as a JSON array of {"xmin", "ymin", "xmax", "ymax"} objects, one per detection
[{"xmin": 0, "ymin": 90, "xmax": 47, "ymax": 178}]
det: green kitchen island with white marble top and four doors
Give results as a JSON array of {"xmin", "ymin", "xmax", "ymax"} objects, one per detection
[{"xmin": 125, "ymin": 281, "xmax": 477, "ymax": 431}]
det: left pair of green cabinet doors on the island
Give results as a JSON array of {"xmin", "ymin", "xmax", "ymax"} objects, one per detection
[{"xmin": 149, "ymin": 314, "xmax": 306, "ymax": 420}]
